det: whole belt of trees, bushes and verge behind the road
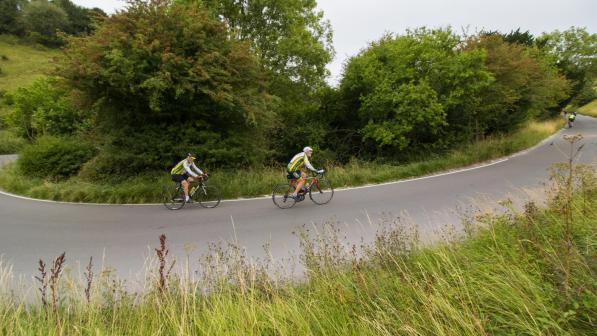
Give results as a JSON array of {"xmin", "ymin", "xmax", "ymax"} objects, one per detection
[{"xmin": 0, "ymin": 0, "xmax": 597, "ymax": 202}]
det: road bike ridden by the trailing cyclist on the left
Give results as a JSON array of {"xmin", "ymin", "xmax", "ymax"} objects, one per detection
[{"xmin": 163, "ymin": 175, "xmax": 222, "ymax": 210}]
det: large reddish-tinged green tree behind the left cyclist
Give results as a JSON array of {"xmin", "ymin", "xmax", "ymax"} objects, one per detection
[{"xmin": 58, "ymin": 0, "xmax": 273, "ymax": 174}]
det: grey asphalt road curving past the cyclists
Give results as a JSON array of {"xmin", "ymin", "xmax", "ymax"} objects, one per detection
[{"xmin": 0, "ymin": 116, "xmax": 597, "ymax": 278}]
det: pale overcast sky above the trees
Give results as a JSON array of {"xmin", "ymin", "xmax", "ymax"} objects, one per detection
[{"xmin": 73, "ymin": 0, "xmax": 597, "ymax": 84}]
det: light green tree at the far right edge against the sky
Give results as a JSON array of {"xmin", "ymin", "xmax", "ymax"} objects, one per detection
[{"xmin": 537, "ymin": 27, "xmax": 597, "ymax": 106}]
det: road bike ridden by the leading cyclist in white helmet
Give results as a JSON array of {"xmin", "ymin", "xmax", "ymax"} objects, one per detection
[{"xmin": 272, "ymin": 173, "xmax": 334, "ymax": 209}]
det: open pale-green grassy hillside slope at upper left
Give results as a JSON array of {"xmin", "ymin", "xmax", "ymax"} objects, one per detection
[{"xmin": 0, "ymin": 35, "xmax": 60, "ymax": 92}]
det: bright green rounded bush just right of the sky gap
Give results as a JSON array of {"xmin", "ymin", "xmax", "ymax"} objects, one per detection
[{"xmin": 334, "ymin": 29, "xmax": 491, "ymax": 154}]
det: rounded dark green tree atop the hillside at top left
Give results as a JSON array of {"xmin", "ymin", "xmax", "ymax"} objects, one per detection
[{"xmin": 22, "ymin": 0, "xmax": 69, "ymax": 47}]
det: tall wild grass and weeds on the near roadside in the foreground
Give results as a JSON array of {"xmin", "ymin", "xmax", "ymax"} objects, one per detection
[{"xmin": 0, "ymin": 159, "xmax": 597, "ymax": 336}]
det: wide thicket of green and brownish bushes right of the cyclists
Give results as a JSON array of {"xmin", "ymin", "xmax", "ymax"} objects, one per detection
[{"xmin": 312, "ymin": 29, "xmax": 568, "ymax": 160}]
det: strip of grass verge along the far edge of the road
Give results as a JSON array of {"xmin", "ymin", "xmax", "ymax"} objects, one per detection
[{"xmin": 0, "ymin": 119, "xmax": 562, "ymax": 203}]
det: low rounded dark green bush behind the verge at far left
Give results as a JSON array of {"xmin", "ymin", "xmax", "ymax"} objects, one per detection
[{"xmin": 17, "ymin": 136, "xmax": 96, "ymax": 179}]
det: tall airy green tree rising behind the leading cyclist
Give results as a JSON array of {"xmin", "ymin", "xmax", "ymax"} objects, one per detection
[{"xmin": 194, "ymin": 0, "xmax": 334, "ymax": 160}]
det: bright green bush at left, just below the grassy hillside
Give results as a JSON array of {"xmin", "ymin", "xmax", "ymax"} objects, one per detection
[{"xmin": 8, "ymin": 77, "xmax": 81, "ymax": 140}]
